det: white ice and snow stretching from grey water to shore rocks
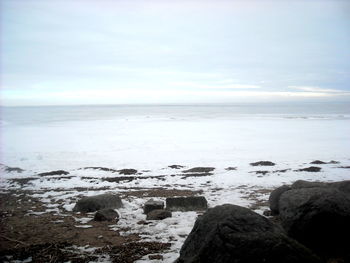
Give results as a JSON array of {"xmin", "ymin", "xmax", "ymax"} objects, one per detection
[{"xmin": 0, "ymin": 105, "xmax": 350, "ymax": 262}]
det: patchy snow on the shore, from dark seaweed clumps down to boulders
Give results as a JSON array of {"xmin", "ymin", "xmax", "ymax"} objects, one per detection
[{"xmin": 0, "ymin": 159, "xmax": 350, "ymax": 262}]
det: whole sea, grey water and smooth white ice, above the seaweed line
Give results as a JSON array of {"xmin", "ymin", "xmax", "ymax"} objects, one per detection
[{"xmin": 0, "ymin": 103, "xmax": 350, "ymax": 170}]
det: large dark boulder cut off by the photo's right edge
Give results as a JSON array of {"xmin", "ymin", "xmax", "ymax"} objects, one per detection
[{"xmin": 279, "ymin": 187, "xmax": 350, "ymax": 258}]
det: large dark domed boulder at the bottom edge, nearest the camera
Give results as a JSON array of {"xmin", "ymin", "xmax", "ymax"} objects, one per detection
[{"xmin": 176, "ymin": 204, "xmax": 320, "ymax": 263}]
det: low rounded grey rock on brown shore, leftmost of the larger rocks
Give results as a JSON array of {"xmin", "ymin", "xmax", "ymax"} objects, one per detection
[{"xmin": 73, "ymin": 194, "xmax": 123, "ymax": 213}]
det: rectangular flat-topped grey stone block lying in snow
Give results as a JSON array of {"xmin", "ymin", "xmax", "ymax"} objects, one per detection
[{"xmin": 166, "ymin": 196, "xmax": 208, "ymax": 211}]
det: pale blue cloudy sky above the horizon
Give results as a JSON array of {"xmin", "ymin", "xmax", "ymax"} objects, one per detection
[{"xmin": 0, "ymin": 0, "xmax": 350, "ymax": 106}]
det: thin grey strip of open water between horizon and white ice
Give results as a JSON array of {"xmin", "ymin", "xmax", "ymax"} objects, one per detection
[{"xmin": 1, "ymin": 103, "xmax": 350, "ymax": 126}]
